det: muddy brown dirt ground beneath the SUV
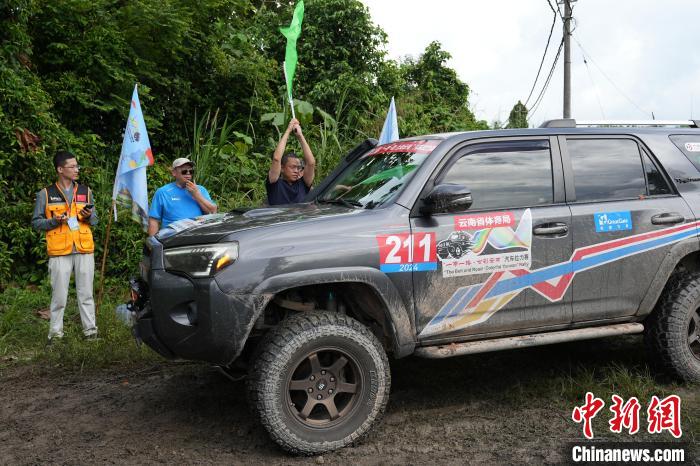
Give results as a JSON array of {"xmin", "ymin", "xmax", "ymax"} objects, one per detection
[{"xmin": 0, "ymin": 337, "xmax": 700, "ymax": 464}]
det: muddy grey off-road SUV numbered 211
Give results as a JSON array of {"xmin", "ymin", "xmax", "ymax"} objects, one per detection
[{"xmin": 131, "ymin": 120, "xmax": 700, "ymax": 454}]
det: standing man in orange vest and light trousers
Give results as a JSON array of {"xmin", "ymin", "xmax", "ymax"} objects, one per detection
[{"xmin": 32, "ymin": 151, "xmax": 97, "ymax": 343}]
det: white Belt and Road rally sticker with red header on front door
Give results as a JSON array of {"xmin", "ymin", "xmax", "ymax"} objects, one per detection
[{"xmin": 436, "ymin": 209, "xmax": 532, "ymax": 278}]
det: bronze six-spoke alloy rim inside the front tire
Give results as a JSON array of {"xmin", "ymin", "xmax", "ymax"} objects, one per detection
[{"xmin": 286, "ymin": 347, "xmax": 364, "ymax": 429}]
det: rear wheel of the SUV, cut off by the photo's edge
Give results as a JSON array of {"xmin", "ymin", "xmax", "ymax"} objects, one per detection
[{"xmin": 644, "ymin": 272, "xmax": 700, "ymax": 382}]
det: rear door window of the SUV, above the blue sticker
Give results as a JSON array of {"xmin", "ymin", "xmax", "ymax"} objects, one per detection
[{"xmin": 567, "ymin": 139, "xmax": 647, "ymax": 202}]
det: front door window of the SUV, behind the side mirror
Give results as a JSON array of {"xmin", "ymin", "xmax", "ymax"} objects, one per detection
[{"xmin": 440, "ymin": 140, "xmax": 553, "ymax": 210}]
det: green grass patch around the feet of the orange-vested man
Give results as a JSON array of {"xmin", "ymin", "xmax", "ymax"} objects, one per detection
[{"xmin": 0, "ymin": 280, "xmax": 162, "ymax": 372}]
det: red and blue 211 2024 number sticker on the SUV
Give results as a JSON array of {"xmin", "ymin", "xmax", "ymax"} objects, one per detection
[{"xmin": 377, "ymin": 232, "xmax": 437, "ymax": 273}]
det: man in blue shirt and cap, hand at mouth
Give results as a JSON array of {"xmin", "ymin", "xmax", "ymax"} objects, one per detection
[{"xmin": 148, "ymin": 157, "xmax": 216, "ymax": 236}]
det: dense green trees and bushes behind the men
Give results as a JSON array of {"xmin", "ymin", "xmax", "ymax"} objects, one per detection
[{"xmin": 0, "ymin": 0, "xmax": 486, "ymax": 286}]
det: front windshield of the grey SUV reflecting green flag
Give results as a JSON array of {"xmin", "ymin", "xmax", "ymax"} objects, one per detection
[{"xmin": 318, "ymin": 139, "xmax": 440, "ymax": 209}]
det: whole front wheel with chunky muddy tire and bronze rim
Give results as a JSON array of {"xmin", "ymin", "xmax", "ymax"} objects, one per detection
[{"xmin": 248, "ymin": 311, "xmax": 391, "ymax": 455}]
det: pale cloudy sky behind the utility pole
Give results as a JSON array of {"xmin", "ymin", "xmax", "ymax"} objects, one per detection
[{"xmin": 362, "ymin": 0, "xmax": 700, "ymax": 126}]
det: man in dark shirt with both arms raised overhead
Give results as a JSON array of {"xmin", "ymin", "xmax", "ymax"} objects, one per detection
[{"xmin": 265, "ymin": 118, "xmax": 316, "ymax": 205}]
